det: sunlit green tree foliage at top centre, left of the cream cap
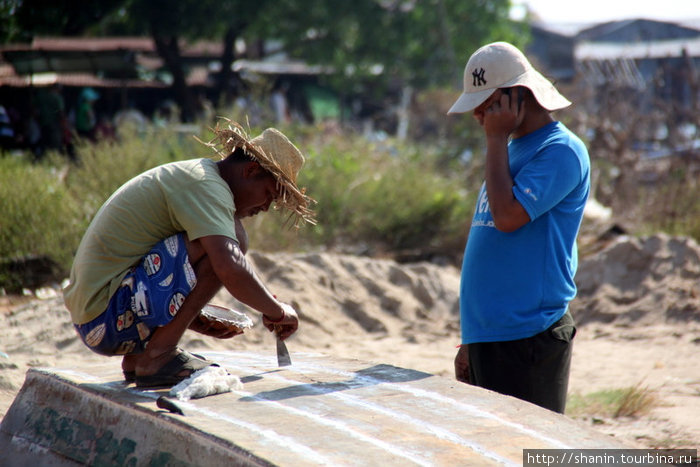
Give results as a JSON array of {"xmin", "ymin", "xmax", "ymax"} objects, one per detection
[{"xmin": 266, "ymin": 0, "xmax": 523, "ymax": 88}]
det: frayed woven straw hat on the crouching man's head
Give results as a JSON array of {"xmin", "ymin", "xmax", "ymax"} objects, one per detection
[{"xmin": 195, "ymin": 117, "xmax": 316, "ymax": 227}]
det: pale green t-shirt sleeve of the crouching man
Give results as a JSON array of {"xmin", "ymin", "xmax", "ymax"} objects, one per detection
[{"xmin": 169, "ymin": 180, "xmax": 238, "ymax": 241}]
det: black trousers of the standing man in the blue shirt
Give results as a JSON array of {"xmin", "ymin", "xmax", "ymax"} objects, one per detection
[{"xmin": 469, "ymin": 311, "xmax": 576, "ymax": 413}]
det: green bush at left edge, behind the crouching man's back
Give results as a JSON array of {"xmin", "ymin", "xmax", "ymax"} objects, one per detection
[{"xmin": 0, "ymin": 128, "xmax": 209, "ymax": 291}]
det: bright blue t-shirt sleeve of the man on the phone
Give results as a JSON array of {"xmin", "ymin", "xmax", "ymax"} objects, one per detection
[{"xmin": 513, "ymin": 144, "xmax": 582, "ymax": 220}]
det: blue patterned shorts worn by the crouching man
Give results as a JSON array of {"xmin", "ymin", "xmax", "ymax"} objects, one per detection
[{"xmin": 75, "ymin": 234, "xmax": 197, "ymax": 355}]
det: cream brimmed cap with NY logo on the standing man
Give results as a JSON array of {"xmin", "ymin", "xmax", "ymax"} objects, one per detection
[{"xmin": 447, "ymin": 42, "xmax": 571, "ymax": 114}]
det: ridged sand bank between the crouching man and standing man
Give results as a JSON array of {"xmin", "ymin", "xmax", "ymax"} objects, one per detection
[{"xmin": 186, "ymin": 252, "xmax": 459, "ymax": 348}]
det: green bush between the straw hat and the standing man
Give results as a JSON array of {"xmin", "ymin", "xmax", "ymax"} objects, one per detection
[{"xmin": 238, "ymin": 126, "xmax": 474, "ymax": 261}]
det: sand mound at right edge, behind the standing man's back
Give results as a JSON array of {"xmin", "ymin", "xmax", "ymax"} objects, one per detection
[{"xmin": 572, "ymin": 234, "xmax": 700, "ymax": 327}]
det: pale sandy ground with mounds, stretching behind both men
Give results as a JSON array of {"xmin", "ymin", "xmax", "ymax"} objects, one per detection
[{"xmin": 0, "ymin": 235, "xmax": 700, "ymax": 448}]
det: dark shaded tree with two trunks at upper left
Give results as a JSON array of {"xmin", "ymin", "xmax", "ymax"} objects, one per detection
[{"xmin": 6, "ymin": 0, "xmax": 267, "ymax": 121}]
